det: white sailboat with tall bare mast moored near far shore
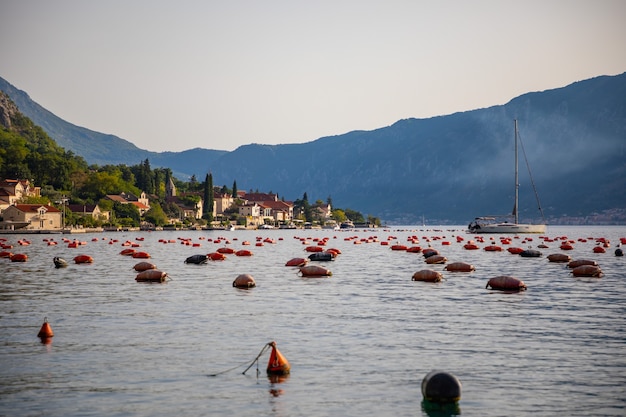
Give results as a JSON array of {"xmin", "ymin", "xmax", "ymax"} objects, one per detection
[{"xmin": 467, "ymin": 120, "xmax": 546, "ymax": 233}]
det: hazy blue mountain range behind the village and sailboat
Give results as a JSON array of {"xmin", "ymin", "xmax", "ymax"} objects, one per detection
[{"xmin": 0, "ymin": 73, "xmax": 626, "ymax": 224}]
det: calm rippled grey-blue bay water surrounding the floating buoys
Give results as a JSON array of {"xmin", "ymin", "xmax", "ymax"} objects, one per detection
[{"xmin": 0, "ymin": 226, "xmax": 626, "ymax": 416}]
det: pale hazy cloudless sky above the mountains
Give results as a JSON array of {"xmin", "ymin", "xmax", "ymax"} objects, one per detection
[{"xmin": 0, "ymin": 0, "xmax": 626, "ymax": 152}]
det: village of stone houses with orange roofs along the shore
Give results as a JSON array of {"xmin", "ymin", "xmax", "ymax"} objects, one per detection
[{"xmin": 0, "ymin": 179, "xmax": 338, "ymax": 233}]
